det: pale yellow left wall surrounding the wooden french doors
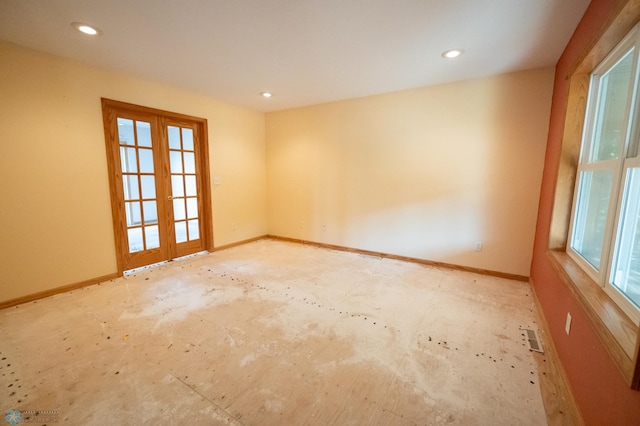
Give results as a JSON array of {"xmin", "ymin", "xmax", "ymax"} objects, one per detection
[{"xmin": 0, "ymin": 42, "xmax": 267, "ymax": 301}]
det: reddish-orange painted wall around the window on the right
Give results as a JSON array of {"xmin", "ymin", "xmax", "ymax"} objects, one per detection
[{"xmin": 531, "ymin": 0, "xmax": 640, "ymax": 425}]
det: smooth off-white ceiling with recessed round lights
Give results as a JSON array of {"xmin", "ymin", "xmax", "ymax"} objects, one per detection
[{"xmin": 0, "ymin": 0, "xmax": 589, "ymax": 111}]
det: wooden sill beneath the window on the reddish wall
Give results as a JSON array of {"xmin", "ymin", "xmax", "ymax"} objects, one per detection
[{"xmin": 547, "ymin": 250, "xmax": 640, "ymax": 389}]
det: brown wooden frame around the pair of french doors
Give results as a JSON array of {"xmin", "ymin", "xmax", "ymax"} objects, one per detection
[{"xmin": 101, "ymin": 98, "xmax": 214, "ymax": 276}]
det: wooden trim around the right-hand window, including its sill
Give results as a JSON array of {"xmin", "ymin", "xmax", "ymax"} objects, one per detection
[{"xmin": 547, "ymin": 0, "xmax": 640, "ymax": 390}]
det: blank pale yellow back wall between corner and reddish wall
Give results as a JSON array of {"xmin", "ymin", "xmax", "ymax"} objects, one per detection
[{"xmin": 266, "ymin": 68, "xmax": 553, "ymax": 276}]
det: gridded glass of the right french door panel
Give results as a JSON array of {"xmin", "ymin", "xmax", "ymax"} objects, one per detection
[{"xmin": 167, "ymin": 126, "xmax": 200, "ymax": 243}]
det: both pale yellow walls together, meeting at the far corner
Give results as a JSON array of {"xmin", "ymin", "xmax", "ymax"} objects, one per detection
[{"xmin": 0, "ymin": 37, "xmax": 553, "ymax": 301}]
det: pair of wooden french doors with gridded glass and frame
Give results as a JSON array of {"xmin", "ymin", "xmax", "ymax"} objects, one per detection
[{"xmin": 102, "ymin": 99, "xmax": 213, "ymax": 274}]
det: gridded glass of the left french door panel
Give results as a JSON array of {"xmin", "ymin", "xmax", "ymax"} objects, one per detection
[{"xmin": 117, "ymin": 118, "xmax": 160, "ymax": 253}]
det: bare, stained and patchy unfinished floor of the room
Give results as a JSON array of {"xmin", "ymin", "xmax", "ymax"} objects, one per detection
[{"xmin": 0, "ymin": 240, "xmax": 547, "ymax": 426}]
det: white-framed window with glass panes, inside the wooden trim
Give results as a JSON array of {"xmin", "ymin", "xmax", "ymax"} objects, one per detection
[{"xmin": 567, "ymin": 27, "xmax": 640, "ymax": 324}]
